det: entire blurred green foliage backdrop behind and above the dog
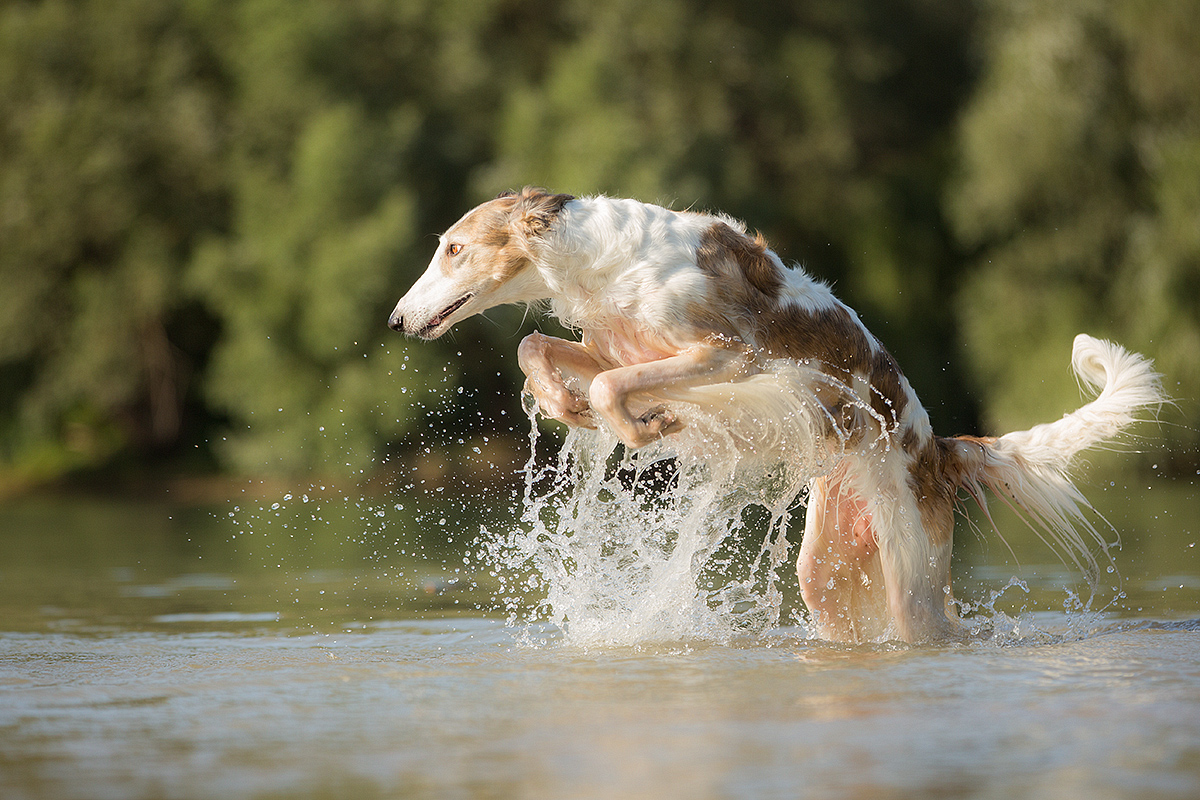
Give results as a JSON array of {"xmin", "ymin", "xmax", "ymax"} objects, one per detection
[{"xmin": 0, "ymin": 0, "xmax": 1200, "ymax": 489}]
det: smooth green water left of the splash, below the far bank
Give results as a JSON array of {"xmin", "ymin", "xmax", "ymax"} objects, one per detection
[{"xmin": 0, "ymin": 491, "xmax": 511, "ymax": 632}]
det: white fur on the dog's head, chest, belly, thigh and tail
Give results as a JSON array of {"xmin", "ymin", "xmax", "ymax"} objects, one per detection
[{"xmin": 391, "ymin": 196, "xmax": 1163, "ymax": 640}]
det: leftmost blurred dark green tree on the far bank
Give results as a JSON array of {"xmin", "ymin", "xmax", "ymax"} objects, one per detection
[{"xmin": 0, "ymin": 0, "xmax": 227, "ymax": 479}]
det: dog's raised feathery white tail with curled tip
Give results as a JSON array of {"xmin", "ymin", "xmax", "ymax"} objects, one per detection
[{"xmin": 944, "ymin": 333, "xmax": 1166, "ymax": 576}]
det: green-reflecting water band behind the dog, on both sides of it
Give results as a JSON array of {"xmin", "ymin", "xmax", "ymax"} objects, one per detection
[{"xmin": 0, "ymin": 480, "xmax": 1200, "ymax": 632}]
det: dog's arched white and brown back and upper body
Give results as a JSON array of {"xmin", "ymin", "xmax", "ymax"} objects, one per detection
[{"xmin": 546, "ymin": 197, "xmax": 928, "ymax": 429}]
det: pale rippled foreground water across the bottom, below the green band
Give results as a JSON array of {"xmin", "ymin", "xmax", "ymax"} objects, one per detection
[{"xmin": 0, "ymin": 619, "xmax": 1200, "ymax": 798}]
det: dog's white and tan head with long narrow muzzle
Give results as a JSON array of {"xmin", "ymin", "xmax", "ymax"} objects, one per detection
[{"xmin": 388, "ymin": 188, "xmax": 575, "ymax": 339}]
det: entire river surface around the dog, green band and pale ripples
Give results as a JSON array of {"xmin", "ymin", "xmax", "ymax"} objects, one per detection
[{"xmin": 0, "ymin": 448, "xmax": 1200, "ymax": 800}]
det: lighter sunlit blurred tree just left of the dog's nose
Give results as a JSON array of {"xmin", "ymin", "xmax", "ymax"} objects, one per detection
[{"xmin": 188, "ymin": 1, "xmax": 432, "ymax": 474}]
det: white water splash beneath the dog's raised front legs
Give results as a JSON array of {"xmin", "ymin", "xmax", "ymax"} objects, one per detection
[{"xmin": 491, "ymin": 429, "xmax": 787, "ymax": 645}]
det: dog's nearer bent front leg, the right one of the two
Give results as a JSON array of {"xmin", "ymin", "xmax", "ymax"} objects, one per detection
[{"xmin": 588, "ymin": 341, "xmax": 752, "ymax": 447}]
